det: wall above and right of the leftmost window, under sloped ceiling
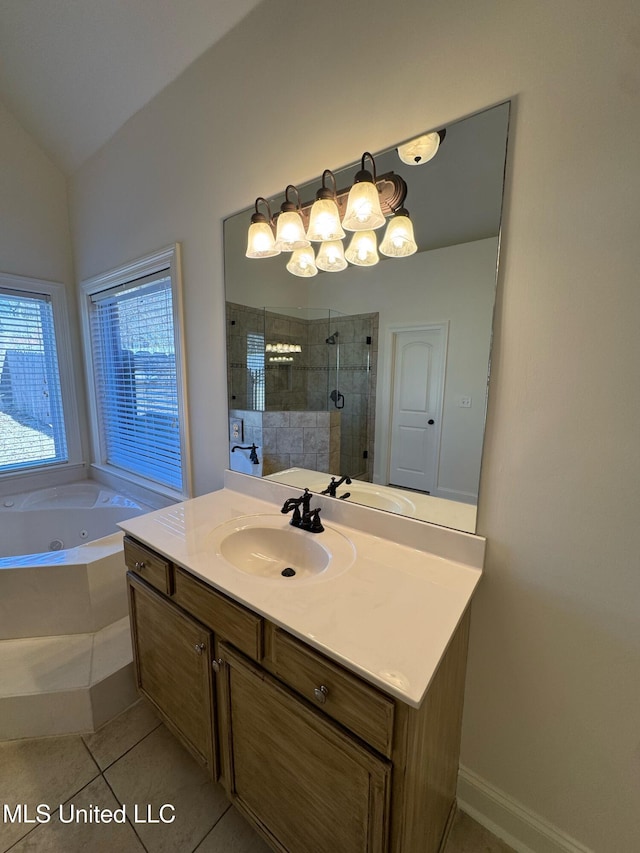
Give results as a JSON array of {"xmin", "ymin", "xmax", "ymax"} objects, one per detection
[{"xmin": 0, "ymin": 102, "xmax": 86, "ymax": 478}]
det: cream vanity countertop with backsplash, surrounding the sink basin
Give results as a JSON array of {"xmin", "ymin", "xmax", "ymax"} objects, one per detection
[{"xmin": 120, "ymin": 472, "xmax": 485, "ymax": 708}]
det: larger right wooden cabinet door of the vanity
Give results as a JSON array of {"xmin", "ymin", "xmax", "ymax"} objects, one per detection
[{"xmin": 218, "ymin": 643, "xmax": 391, "ymax": 853}]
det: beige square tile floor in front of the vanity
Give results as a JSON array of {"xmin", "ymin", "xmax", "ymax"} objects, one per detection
[{"xmin": 0, "ymin": 700, "xmax": 512, "ymax": 853}]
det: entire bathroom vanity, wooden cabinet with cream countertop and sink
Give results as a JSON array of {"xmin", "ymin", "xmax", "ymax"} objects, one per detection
[{"xmin": 122, "ymin": 474, "xmax": 484, "ymax": 853}]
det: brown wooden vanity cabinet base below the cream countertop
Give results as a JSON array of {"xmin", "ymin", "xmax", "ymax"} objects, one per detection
[{"xmin": 125, "ymin": 537, "xmax": 469, "ymax": 853}]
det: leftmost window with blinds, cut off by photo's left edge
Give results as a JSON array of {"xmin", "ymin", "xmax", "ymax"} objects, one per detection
[{"xmin": 0, "ymin": 274, "xmax": 79, "ymax": 474}]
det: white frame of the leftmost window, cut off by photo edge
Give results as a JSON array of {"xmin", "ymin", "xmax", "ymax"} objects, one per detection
[{"xmin": 0, "ymin": 272, "xmax": 83, "ymax": 482}]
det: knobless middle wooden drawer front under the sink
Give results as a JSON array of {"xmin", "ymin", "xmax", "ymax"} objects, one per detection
[{"xmin": 173, "ymin": 566, "xmax": 262, "ymax": 660}]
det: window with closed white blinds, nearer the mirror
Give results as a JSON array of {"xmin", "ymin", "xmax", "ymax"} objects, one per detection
[{"xmin": 83, "ymin": 249, "xmax": 189, "ymax": 496}]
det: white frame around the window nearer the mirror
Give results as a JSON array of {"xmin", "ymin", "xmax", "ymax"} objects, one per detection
[{"xmin": 80, "ymin": 243, "xmax": 192, "ymax": 500}]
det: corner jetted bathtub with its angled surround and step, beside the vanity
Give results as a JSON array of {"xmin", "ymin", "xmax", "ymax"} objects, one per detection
[{"xmin": 0, "ymin": 481, "xmax": 159, "ymax": 740}]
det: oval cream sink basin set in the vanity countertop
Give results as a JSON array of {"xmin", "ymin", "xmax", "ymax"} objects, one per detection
[{"xmin": 209, "ymin": 514, "xmax": 355, "ymax": 583}]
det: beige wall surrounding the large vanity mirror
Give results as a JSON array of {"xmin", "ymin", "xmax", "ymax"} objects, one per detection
[{"xmin": 67, "ymin": 0, "xmax": 640, "ymax": 853}]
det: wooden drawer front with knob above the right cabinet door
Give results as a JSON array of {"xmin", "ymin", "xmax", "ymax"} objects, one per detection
[{"xmin": 268, "ymin": 628, "xmax": 395, "ymax": 757}]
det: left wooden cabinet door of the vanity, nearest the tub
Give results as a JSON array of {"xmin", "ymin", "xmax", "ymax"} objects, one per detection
[{"xmin": 128, "ymin": 574, "xmax": 217, "ymax": 777}]
